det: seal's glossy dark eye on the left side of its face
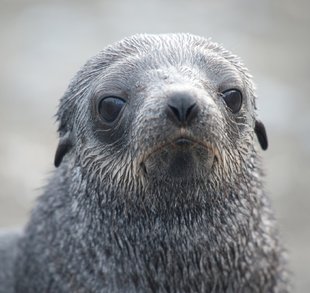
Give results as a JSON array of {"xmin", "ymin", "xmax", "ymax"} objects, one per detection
[{"xmin": 98, "ymin": 96, "xmax": 125, "ymax": 123}]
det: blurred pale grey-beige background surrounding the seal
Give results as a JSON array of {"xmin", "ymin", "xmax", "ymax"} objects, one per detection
[{"xmin": 0, "ymin": 0, "xmax": 310, "ymax": 292}]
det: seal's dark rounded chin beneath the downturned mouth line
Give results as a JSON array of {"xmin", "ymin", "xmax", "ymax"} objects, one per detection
[{"xmin": 143, "ymin": 137, "xmax": 215, "ymax": 180}]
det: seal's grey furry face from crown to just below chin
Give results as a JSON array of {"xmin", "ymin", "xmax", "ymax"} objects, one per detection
[{"xmin": 55, "ymin": 34, "xmax": 264, "ymax": 203}]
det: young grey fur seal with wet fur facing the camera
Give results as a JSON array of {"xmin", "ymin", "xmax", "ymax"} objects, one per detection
[{"xmin": 0, "ymin": 34, "xmax": 288, "ymax": 293}]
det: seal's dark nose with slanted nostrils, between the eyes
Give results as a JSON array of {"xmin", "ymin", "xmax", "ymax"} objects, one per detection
[{"xmin": 166, "ymin": 92, "xmax": 198, "ymax": 124}]
